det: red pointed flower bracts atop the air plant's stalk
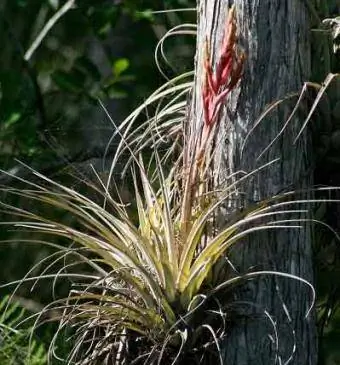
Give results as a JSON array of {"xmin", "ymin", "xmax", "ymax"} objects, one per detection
[{"xmin": 202, "ymin": 6, "xmax": 245, "ymax": 127}]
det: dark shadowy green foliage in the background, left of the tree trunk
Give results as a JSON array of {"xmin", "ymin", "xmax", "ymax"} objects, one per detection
[{"xmin": 0, "ymin": 0, "xmax": 196, "ymax": 358}]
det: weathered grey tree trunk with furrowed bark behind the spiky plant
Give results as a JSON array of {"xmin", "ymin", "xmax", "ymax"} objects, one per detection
[{"xmin": 192, "ymin": 0, "xmax": 317, "ymax": 365}]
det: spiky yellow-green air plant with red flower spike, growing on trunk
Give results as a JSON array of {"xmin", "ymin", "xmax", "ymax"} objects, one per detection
[{"xmin": 2, "ymin": 4, "xmax": 330, "ymax": 365}]
